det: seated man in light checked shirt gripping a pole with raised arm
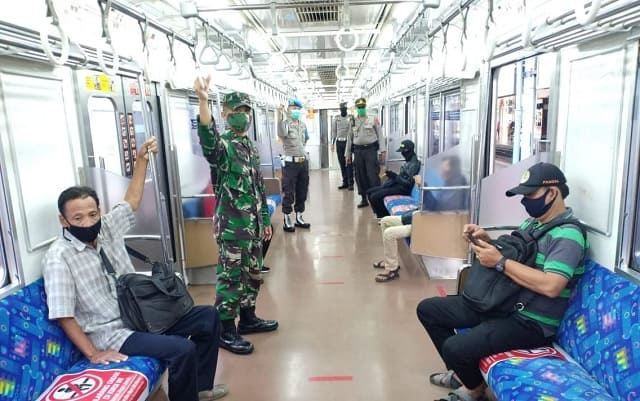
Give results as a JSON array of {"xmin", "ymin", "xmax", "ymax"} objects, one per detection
[{"xmin": 43, "ymin": 138, "xmax": 227, "ymax": 401}]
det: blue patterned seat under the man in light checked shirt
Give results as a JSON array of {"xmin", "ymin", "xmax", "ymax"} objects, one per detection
[{"xmin": 0, "ymin": 278, "xmax": 165, "ymax": 401}]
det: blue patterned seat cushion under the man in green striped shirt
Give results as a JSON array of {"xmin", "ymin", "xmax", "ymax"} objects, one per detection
[{"xmin": 480, "ymin": 347, "xmax": 615, "ymax": 401}]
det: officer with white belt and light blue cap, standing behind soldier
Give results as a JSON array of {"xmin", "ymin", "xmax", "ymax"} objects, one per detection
[{"xmin": 278, "ymin": 99, "xmax": 311, "ymax": 232}]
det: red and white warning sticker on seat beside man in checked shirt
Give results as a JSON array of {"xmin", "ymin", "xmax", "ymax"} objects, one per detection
[{"xmin": 36, "ymin": 369, "xmax": 149, "ymax": 401}]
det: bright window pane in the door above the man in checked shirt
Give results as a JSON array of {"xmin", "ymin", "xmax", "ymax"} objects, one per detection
[{"xmin": 88, "ymin": 97, "xmax": 122, "ymax": 175}]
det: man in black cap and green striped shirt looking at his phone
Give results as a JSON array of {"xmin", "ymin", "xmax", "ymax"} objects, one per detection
[{"xmin": 417, "ymin": 163, "xmax": 586, "ymax": 401}]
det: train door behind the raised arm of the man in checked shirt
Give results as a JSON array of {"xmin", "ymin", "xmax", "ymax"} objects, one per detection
[{"xmin": 75, "ymin": 70, "xmax": 171, "ymax": 268}]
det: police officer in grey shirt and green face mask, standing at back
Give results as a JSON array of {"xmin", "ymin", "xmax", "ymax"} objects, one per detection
[{"xmin": 344, "ymin": 98, "xmax": 382, "ymax": 208}]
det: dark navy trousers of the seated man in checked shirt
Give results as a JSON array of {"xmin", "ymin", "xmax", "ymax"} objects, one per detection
[{"xmin": 120, "ymin": 305, "xmax": 220, "ymax": 401}]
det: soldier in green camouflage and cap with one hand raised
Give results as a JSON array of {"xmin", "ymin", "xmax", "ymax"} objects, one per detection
[{"xmin": 194, "ymin": 78, "xmax": 278, "ymax": 354}]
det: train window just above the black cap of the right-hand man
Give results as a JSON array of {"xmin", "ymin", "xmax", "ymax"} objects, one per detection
[{"xmin": 490, "ymin": 54, "xmax": 555, "ymax": 173}]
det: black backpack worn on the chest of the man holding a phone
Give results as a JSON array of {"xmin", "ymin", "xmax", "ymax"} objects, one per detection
[{"xmin": 462, "ymin": 218, "xmax": 587, "ymax": 316}]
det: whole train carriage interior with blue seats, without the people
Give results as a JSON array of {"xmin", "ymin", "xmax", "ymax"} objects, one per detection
[{"xmin": 0, "ymin": 0, "xmax": 640, "ymax": 401}]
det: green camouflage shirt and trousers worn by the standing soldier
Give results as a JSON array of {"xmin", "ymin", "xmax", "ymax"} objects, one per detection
[{"xmin": 198, "ymin": 94, "xmax": 271, "ymax": 320}]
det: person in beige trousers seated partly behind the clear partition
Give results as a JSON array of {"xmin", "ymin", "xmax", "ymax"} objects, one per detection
[{"xmin": 373, "ymin": 156, "xmax": 469, "ymax": 283}]
